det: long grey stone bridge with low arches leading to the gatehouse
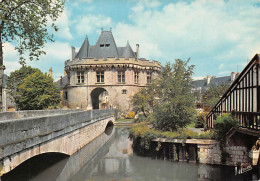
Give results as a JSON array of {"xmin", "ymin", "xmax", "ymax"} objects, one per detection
[{"xmin": 0, "ymin": 109, "xmax": 115, "ymax": 177}]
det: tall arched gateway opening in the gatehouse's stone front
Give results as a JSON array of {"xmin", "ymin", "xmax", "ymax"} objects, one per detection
[{"xmin": 90, "ymin": 87, "xmax": 109, "ymax": 109}]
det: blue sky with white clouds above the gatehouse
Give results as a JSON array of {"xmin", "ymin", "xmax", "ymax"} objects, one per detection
[{"xmin": 3, "ymin": 0, "xmax": 260, "ymax": 80}]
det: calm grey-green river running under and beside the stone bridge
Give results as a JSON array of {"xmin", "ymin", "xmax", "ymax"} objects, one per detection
[{"xmin": 2, "ymin": 128, "xmax": 256, "ymax": 181}]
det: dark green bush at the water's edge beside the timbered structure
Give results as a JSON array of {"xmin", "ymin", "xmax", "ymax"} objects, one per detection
[{"xmin": 214, "ymin": 114, "xmax": 238, "ymax": 140}]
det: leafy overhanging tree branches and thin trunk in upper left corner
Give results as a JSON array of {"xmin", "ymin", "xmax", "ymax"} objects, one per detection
[{"xmin": 0, "ymin": 0, "xmax": 64, "ymax": 109}]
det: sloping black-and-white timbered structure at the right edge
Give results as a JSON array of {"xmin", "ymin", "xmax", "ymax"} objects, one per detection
[{"xmin": 206, "ymin": 54, "xmax": 260, "ymax": 129}]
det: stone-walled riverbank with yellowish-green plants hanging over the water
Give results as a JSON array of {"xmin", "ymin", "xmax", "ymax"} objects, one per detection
[{"xmin": 130, "ymin": 122, "xmax": 252, "ymax": 166}]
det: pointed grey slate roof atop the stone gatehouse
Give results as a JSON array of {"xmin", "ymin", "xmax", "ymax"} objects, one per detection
[{"xmin": 75, "ymin": 31, "xmax": 136, "ymax": 59}]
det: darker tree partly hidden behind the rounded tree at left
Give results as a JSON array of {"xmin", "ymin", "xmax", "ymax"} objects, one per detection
[{"xmin": 7, "ymin": 66, "xmax": 39, "ymax": 103}]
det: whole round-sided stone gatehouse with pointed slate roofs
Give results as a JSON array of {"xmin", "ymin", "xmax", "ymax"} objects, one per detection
[{"xmin": 58, "ymin": 31, "xmax": 161, "ymax": 112}]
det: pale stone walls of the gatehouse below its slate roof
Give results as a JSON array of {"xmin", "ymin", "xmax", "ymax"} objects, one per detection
[{"xmin": 64, "ymin": 58, "xmax": 161, "ymax": 112}]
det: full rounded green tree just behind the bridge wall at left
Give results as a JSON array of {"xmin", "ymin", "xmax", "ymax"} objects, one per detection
[{"xmin": 17, "ymin": 70, "xmax": 60, "ymax": 110}]
